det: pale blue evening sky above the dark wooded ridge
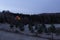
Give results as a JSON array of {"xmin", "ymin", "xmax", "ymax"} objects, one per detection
[{"xmin": 0, "ymin": 0, "xmax": 60, "ymax": 14}]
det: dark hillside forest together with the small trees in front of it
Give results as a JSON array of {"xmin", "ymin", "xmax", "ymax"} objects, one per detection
[{"xmin": 0, "ymin": 11, "xmax": 60, "ymax": 39}]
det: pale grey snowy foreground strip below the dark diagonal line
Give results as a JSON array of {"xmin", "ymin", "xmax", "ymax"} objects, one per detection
[{"xmin": 0, "ymin": 31, "xmax": 48, "ymax": 40}]
